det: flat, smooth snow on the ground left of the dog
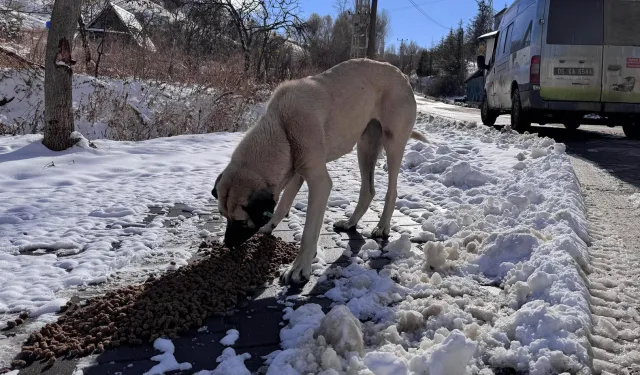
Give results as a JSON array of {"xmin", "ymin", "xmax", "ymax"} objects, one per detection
[{"xmin": 0, "ymin": 133, "xmax": 241, "ymax": 314}]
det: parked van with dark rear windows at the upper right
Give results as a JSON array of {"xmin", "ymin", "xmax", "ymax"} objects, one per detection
[{"xmin": 478, "ymin": 0, "xmax": 640, "ymax": 139}]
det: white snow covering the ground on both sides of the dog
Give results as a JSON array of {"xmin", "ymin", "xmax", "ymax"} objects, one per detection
[{"xmin": 0, "ymin": 100, "xmax": 592, "ymax": 375}]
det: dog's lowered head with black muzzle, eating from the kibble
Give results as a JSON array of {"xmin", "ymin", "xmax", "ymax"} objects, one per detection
[{"xmin": 211, "ymin": 167, "xmax": 276, "ymax": 247}]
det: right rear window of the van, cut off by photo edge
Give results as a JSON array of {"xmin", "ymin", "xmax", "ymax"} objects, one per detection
[{"xmin": 604, "ymin": 0, "xmax": 640, "ymax": 46}]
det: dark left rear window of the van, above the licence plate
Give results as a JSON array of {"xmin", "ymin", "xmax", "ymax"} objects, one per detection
[{"xmin": 547, "ymin": 0, "xmax": 604, "ymax": 45}]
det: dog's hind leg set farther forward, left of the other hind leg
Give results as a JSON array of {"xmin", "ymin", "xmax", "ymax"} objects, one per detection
[{"xmin": 333, "ymin": 120, "xmax": 382, "ymax": 231}]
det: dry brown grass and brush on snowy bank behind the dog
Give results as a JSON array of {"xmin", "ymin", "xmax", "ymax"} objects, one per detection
[{"xmin": 0, "ymin": 31, "xmax": 284, "ymax": 141}]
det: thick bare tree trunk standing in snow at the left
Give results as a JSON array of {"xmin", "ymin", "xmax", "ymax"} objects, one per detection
[{"xmin": 42, "ymin": 0, "xmax": 82, "ymax": 151}]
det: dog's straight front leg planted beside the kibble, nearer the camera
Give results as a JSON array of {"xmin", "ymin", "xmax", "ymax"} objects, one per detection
[{"xmin": 282, "ymin": 164, "xmax": 332, "ymax": 284}]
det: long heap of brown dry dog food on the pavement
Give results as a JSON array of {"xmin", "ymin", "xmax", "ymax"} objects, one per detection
[{"xmin": 13, "ymin": 235, "xmax": 298, "ymax": 367}]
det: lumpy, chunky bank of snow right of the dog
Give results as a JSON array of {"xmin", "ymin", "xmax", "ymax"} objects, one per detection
[{"xmin": 266, "ymin": 117, "xmax": 591, "ymax": 375}]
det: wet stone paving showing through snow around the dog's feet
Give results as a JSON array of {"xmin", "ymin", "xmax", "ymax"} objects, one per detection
[{"xmin": 13, "ymin": 159, "xmax": 421, "ymax": 375}]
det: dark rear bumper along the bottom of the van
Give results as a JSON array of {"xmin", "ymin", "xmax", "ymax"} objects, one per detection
[{"xmin": 520, "ymin": 84, "xmax": 640, "ymax": 114}]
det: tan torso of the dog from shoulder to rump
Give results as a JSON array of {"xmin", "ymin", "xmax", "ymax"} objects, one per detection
[{"xmin": 267, "ymin": 59, "xmax": 416, "ymax": 160}]
